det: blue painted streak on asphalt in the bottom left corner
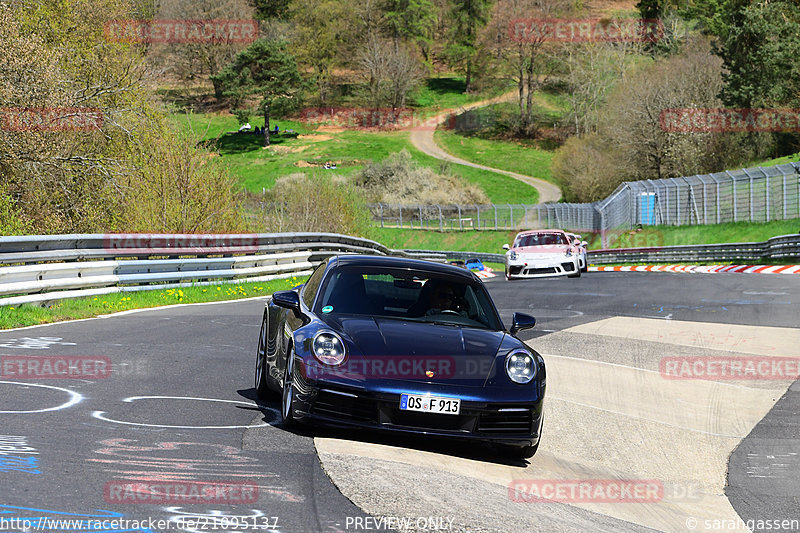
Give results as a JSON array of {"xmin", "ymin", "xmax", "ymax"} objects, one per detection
[{"xmin": 0, "ymin": 504, "xmax": 156, "ymax": 533}]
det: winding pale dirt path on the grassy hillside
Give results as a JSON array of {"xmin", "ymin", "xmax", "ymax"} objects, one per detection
[{"xmin": 411, "ymin": 91, "xmax": 561, "ymax": 203}]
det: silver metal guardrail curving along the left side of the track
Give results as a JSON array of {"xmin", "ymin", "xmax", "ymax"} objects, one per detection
[{"xmin": 0, "ymin": 233, "xmax": 444, "ymax": 306}]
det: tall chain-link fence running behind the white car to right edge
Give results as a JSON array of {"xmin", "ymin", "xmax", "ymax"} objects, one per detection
[{"xmin": 369, "ymin": 158, "xmax": 800, "ymax": 241}]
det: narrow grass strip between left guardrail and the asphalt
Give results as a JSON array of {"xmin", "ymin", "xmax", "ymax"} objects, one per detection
[{"xmin": 0, "ymin": 278, "xmax": 305, "ymax": 329}]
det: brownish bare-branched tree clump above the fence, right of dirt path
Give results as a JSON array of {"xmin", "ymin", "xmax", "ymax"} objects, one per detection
[{"xmin": 553, "ymin": 38, "xmax": 758, "ymax": 201}]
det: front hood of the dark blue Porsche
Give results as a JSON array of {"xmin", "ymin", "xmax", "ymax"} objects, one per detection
[{"xmin": 316, "ymin": 315, "xmax": 506, "ymax": 386}]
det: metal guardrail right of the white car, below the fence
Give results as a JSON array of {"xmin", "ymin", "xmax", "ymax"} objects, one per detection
[{"xmin": 588, "ymin": 234, "xmax": 800, "ymax": 265}]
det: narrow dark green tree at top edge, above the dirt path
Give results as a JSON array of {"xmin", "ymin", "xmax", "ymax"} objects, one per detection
[{"xmin": 446, "ymin": 0, "xmax": 494, "ymax": 92}]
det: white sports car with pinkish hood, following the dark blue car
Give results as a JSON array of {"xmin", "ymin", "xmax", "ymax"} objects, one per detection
[{"xmin": 503, "ymin": 229, "xmax": 581, "ymax": 281}]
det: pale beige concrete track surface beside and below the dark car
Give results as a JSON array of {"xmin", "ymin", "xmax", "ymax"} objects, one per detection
[{"xmin": 316, "ymin": 317, "xmax": 800, "ymax": 532}]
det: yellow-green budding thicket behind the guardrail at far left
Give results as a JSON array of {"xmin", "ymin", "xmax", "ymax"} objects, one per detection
[{"xmin": 0, "ymin": 0, "xmax": 242, "ymax": 233}]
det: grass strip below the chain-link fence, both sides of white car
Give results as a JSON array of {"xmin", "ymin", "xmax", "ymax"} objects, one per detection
[{"xmin": 371, "ymin": 219, "xmax": 800, "ymax": 253}]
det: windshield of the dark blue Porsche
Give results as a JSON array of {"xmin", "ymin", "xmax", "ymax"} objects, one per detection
[{"xmin": 314, "ymin": 267, "xmax": 503, "ymax": 331}]
